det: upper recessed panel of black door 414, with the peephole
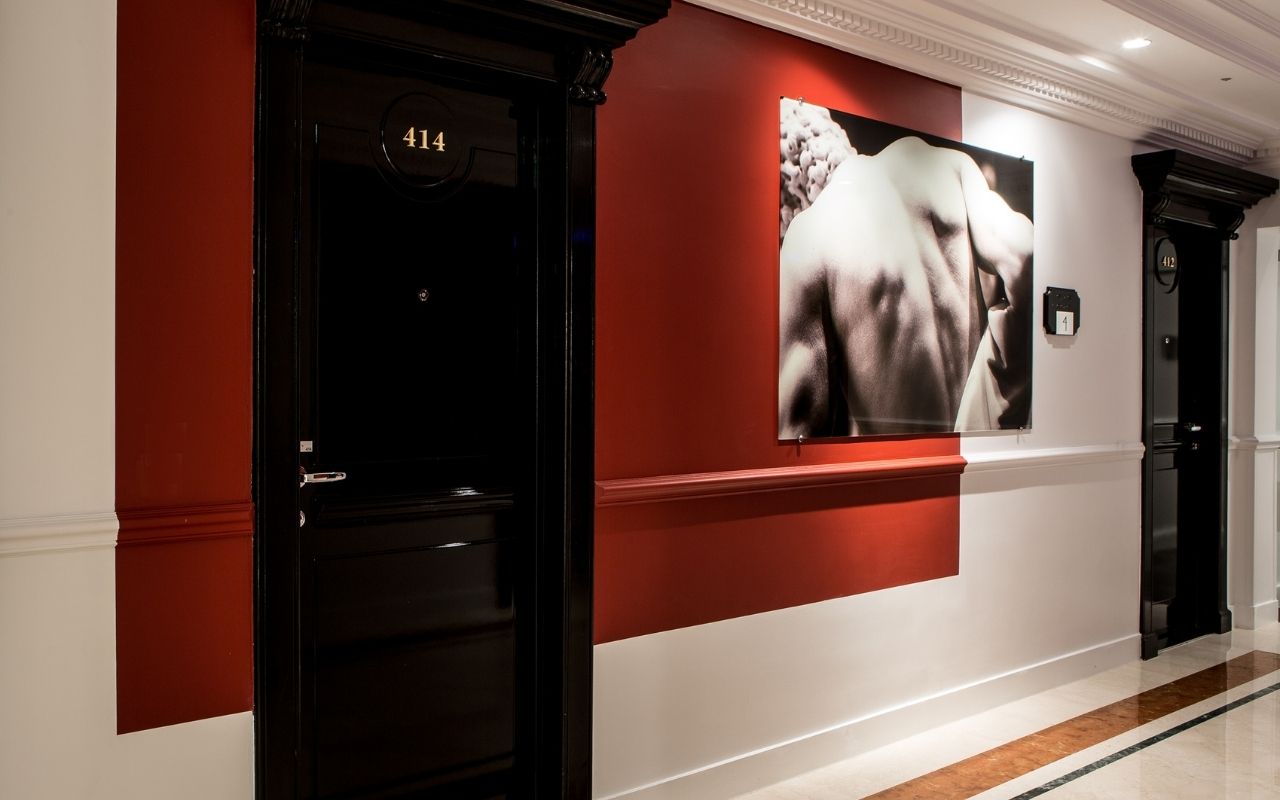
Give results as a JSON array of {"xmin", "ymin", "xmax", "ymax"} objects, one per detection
[{"xmin": 312, "ymin": 76, "xmax": 521, "ymax": 484}]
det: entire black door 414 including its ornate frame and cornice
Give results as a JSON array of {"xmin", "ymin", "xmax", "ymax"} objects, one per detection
[{"xmin": 253, "ymin": 0, "xmax": 669, "ymax": 800}]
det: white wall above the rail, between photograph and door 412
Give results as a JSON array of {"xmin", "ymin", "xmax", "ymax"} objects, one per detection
[{"xmin": 961, "ymin": 93, "xmax": 1142, "ymax": 456}]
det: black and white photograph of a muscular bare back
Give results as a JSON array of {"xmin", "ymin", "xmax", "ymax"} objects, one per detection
[{"xmin": 778, "ymin": 97, "xmax": 1033, "ymax": 440}]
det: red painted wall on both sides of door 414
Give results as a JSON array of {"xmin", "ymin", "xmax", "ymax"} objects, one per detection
[{"xmin": 116, "ymin": 0, "xmax": 960, "ymax": 732}]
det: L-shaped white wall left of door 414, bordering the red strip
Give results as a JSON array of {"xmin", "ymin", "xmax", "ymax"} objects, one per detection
[{"xmin": 0, "ymin": 0, "xmax": 252, "ymax": 800}]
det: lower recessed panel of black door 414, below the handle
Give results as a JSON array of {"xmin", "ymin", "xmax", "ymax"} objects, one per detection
[{"xmin": 314, "ymin": 541, "xmax": 516, "ymax": 796}]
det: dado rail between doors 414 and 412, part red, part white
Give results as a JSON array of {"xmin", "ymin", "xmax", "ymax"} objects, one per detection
[{"xmin": 595, "ymin": 442, "xmax": 1143, "ymax": 507}]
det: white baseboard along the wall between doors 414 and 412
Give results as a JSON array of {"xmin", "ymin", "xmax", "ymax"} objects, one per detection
[{"xmin": 600, "ymin": 634, "xmax": 1140, "ymax": 800}]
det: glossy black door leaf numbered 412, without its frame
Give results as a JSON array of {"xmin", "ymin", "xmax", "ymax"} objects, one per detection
[{"xmin": 1144, "ymin": 223, "xmax": 1229, "ymax": 654}]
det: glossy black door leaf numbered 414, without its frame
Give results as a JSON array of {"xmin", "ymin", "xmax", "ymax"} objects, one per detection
[{"xmin": 298, "ymin": 63, "xmax": 536, "ymax": 799}]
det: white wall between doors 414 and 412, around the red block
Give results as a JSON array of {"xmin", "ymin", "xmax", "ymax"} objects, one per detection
[{"xmin": 594, "ymin": 96, "xmax": 1142, "ymax": 800}]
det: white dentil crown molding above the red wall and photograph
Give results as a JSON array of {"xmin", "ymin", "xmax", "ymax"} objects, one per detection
[{"xmin": 690, "ymin": 0, "xmax": 1264, "ymax": 165}]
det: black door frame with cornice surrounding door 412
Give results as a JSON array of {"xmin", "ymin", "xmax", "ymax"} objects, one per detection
[{"xmin": 1133, "ymin": 150, "xmax": 1277, "ymax": 658}]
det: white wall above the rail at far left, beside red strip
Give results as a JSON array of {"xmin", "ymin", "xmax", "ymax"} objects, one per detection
[{"xmin": 0, "ymin": 0, "xmax": 115, "ymax": 520}]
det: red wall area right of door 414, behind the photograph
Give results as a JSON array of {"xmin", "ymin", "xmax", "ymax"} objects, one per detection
[{"xmin": 595, "ymin": 1, "xmax": 963, "ymax": 641}]
